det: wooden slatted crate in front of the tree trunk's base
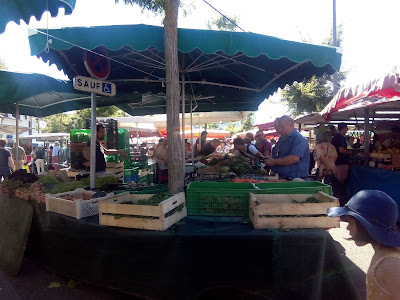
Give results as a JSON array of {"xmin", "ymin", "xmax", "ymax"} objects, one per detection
[{"xmin": 99, "ymin": 192, "xmax": 187, "ymax": 231}]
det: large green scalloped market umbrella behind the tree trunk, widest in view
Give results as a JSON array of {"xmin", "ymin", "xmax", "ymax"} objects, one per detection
[{"xmin": 29, "ymin": 25, "xmax": 341, "ymax": 115}]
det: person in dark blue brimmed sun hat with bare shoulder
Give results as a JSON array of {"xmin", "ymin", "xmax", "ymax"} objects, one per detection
[{"xmin": 328, "ymin": 190, "xmax": 400, "ymax": 300}]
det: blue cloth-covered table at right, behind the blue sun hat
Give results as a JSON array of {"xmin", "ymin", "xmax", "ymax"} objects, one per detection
[{"xmin": 348, "ymin": 166, "xmax": 400, "ymax": 222}]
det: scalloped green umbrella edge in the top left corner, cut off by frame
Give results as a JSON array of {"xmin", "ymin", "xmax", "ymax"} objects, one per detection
[{"xmin": 0, "ymin": 0, "xmax": 76, "ymax": 34}]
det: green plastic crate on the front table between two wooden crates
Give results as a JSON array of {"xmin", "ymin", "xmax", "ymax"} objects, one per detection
[{"xmin": 186, "ymin": 182, "xmax": 256, "ymax": 217}]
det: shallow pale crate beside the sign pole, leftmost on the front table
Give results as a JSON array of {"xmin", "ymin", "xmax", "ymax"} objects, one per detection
[{"xmin": 46, "ymin": 188, "xmax": 125, "ymax": 219}]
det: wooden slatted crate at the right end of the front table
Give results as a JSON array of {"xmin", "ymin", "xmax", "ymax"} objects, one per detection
[{"xmin": 249, "ymin": 192, "xmax": 340, "ymax": 229}]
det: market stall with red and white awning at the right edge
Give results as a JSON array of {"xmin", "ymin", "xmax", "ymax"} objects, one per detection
[{"xmin": 295, "ymin": 68, "xmax": 400, "ymax": 210}]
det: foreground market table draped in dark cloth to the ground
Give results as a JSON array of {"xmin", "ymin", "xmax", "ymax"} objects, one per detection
[{"xmin": 26, "ymin": 204, "xmax": 359, "ymax": 300}]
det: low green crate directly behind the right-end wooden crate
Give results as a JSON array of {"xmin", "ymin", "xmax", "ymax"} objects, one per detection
[{"xmin": 256, "ymin": 181, "xmax": 332, "ymax": 195}]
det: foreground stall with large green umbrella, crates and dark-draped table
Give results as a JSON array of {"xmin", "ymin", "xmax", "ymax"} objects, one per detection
[{"xmin": 2, "ymin": 25, "xmax": 357, "ymax": 299}]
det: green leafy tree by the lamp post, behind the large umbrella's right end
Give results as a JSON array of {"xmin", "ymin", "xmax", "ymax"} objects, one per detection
[{"xmin": 281, "ymin": 25, "xmax": 347, "ymax": 117}]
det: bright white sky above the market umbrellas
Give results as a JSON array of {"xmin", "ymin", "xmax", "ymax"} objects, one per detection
[{"xmin": 0, "ymin": 0, "xmax": 400, "ymax": 122}]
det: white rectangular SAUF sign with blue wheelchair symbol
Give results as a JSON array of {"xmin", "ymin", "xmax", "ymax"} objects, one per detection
[{"xmin": 73, "ymin": 76, "xmax": 117, "ymax": 96}]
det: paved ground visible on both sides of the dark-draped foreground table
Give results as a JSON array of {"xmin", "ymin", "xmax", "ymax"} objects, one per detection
[{"xmin": 0, "ymin": 222, "xmax": 374, "ymax": 300}]
